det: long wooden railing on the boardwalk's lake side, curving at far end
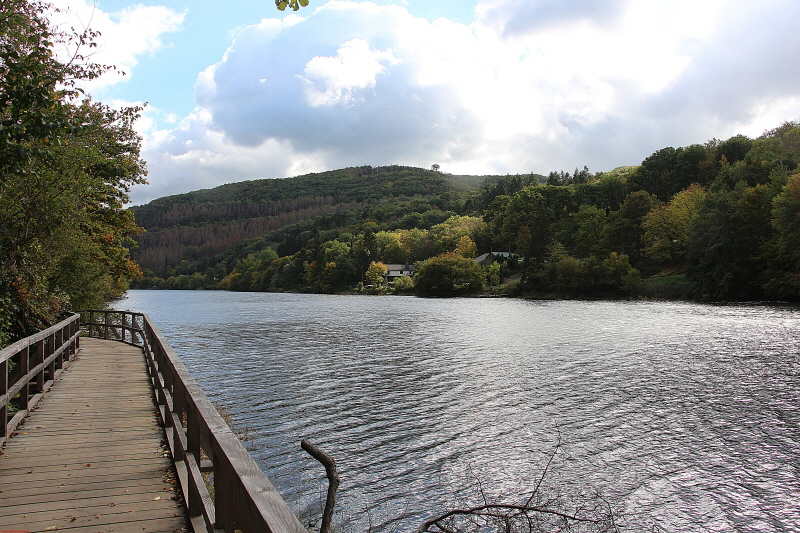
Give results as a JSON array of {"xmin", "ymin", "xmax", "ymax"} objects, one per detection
[{"xmin": 84, "ymin": 311, "xmax": 306, "ymax": 533}]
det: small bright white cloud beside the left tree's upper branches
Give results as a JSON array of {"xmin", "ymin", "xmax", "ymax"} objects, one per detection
[{"xmin": 50, "ymin": 0, "xmax": 186, "ymax": 93}]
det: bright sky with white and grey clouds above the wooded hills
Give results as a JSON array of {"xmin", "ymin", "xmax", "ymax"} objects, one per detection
[{"xmin": 51, "ymin": 0, "xmax": 800, "ymax": 204}]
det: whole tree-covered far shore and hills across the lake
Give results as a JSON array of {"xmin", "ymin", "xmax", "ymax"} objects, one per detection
[{"xmin": 130, "ymin": 122, "xmax": 800, "ymax": 300}]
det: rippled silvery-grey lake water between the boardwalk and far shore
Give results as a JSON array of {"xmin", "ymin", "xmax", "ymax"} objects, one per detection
[{"xmin": 113, "ymin": 291, "xmax": 800, "ymax": 532}]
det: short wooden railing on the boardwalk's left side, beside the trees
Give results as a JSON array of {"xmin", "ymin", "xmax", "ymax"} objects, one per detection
[{"xmin": 0, "ymin": 315, "xmax": 81, "ymax": 445}]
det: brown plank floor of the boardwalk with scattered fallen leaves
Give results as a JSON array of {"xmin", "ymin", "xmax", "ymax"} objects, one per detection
[{"xmin": 0, "ymin": 338, "xmax": 187, "ymax": 533}]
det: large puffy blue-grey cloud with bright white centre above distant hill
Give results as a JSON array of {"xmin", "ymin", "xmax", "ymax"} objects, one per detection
[{"xmin": 198, "ymin": 2, "xmax": 484, "ymax": 156}]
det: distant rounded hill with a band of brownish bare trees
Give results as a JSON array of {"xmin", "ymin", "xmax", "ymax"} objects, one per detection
[{"xmin": 131, "ymin": 166, "xmax": 483, "ymax": 277}]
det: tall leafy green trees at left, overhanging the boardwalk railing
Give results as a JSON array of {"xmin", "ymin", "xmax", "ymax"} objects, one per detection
[{"xmin": 0, "ymin": 0, "xmax": 145, "ymax": 346}]
